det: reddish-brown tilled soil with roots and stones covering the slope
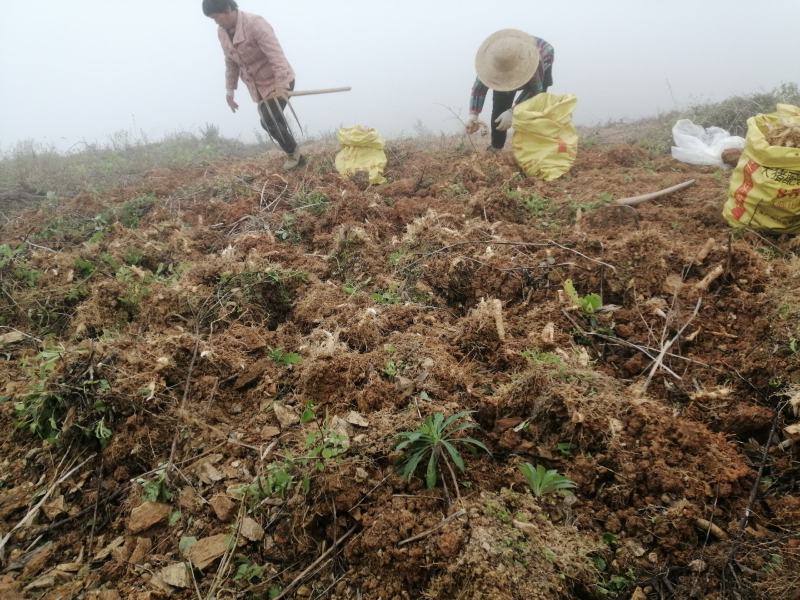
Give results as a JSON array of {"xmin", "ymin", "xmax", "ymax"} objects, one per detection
[{"xmin": 0, "ymin": 143, "xmax": 800, "ymax": 600}]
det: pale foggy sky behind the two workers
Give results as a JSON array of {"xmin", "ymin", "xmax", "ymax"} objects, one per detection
[{"xmin": 0, "ymin": 0, "xmax": 800, "ymax": 150}]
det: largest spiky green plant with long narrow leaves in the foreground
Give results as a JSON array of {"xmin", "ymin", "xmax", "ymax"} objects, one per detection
[{"xmin": 395, "ymin": 411, "xmax": 490, "ymax": 493}]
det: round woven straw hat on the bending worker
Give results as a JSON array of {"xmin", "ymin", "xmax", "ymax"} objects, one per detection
[{"xmin": 475, "ymin": 29, "xmax": 539, "ymax": 92}]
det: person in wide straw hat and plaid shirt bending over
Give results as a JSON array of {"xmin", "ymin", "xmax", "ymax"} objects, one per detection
[{"xmin": 466, "ymin": 29, "xmax": 555, "ymax": 150}]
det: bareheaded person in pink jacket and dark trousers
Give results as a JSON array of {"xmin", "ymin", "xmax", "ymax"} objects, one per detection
[{"xmin": 203, "ymin": 0, "xmax": 303, "ymax": 171}]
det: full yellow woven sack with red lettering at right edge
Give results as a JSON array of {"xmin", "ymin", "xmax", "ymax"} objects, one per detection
[{"xmin": 722, "ymin": 104, "xmax": 800, "ymax": 233}]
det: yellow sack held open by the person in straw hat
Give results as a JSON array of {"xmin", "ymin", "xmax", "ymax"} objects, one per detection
[{"xmin": 511, "ymin": 92, "xmax": 578, "ymax": 181}]
